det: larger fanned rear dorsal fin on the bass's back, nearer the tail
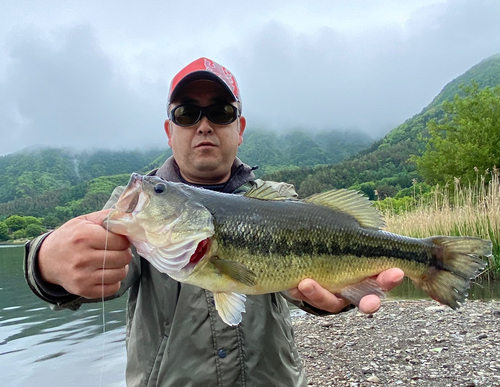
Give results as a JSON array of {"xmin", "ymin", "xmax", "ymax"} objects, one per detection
[{"xmin": 304, "ymin": 189, "xmax": 385, "ymax": 229}]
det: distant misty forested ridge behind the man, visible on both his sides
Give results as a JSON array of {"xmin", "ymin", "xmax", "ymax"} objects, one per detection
[{"xmin": 0, "ymin": 130, "xmax": 372, "ymax": 227}]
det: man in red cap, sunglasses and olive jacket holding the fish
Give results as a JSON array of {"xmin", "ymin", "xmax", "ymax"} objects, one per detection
[{"xmin": 26, "ymin": 58, "xmax": 403, "ymax": 387}]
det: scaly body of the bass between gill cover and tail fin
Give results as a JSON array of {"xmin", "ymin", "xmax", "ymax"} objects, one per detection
[{"xmin": 152, "ymin": 186, "xmax": 450, "ymax": 294}]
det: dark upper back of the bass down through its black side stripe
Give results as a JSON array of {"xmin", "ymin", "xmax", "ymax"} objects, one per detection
[{"xmin": 203, "ymin": 195, "xmax": 434, "ymax": 264}]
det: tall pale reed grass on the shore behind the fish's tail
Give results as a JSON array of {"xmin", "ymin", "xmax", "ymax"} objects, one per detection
[{"xmin": 382, "ymin": 168, "xmax": 500, "ymax": 278}]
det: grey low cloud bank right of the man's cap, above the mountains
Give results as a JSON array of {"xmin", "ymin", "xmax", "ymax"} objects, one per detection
[{"xmin": 234, "ymin": 2, "xmax": 500, "ymax": 136}]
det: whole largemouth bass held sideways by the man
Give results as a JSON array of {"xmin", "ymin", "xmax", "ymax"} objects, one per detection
[{"xmin": 103, "ymin": 174, "xmax": 492, "ymax": 325}]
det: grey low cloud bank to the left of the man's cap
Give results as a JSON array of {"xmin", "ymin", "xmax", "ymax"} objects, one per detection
[{"xmin": 0, "ymin": 26, "xmax": 167, "ymax": 153}]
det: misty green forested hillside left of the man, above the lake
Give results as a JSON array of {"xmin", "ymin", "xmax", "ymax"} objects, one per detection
[{"xmin": 0, "ymin": 147, "xmax": 163, "ymax": 226}]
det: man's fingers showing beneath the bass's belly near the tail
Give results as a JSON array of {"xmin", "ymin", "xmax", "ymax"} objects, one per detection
[{"xmin": 289, "ymin": 268, "xmax": 404, "ymax": 314}]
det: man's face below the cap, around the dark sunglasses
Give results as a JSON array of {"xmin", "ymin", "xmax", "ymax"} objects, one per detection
[{"xmin": 165, "ymin": 81, "xmax": 246, "ymax": 184}]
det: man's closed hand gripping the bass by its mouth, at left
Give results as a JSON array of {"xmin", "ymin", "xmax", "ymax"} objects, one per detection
[{"xmin": 38, "ymin": 210, "xmax": 132, "ymax": 298}]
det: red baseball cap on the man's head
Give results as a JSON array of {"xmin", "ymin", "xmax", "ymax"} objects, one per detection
[{"xmin": 167, "ymin": 58, "xmax": 241, "ymax": 105}]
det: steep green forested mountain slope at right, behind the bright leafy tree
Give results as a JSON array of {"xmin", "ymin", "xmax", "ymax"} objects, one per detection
[{"xmin": 264, "ymin": 54, "xmax": 500, "ymax": 199}]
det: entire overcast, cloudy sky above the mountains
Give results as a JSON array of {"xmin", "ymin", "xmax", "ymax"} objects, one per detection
[{"xmin": 0, "ymin": 0, "xmax": 500, "ymax": 155}]
